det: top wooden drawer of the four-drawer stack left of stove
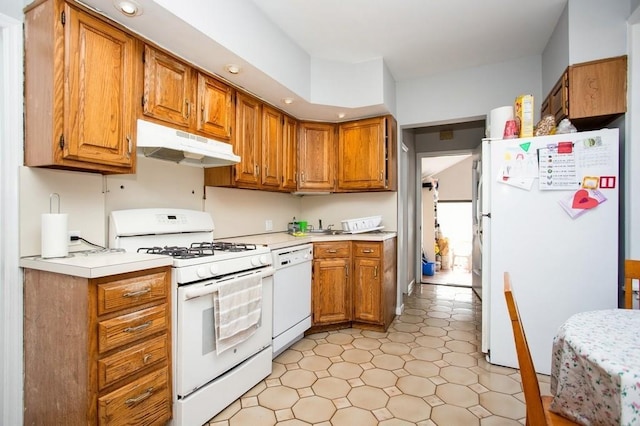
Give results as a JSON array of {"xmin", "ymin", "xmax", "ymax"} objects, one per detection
[{"xmin": 98, "ymin": 271, "xmax": 169, "ymax": 315}]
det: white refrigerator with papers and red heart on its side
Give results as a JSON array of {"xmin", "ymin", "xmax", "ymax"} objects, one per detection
[{"xmin": 474, "ymin": 129, "xmax": 620, "ymax": 374}]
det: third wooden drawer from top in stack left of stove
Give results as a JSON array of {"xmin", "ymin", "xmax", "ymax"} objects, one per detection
[{"xmin": 98, "ymin": 334, "xmax": 168, "ymax": 389}]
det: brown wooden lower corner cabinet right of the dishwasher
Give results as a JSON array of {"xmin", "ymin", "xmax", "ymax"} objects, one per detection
[{"xmin": 307, "ymin": 238, "xmax": 397, "ymax": 334}]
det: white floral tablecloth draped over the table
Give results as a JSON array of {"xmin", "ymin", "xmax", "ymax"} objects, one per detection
[{"xmin": 551, "ymin": 309, "xmax": 640, "ymax": 425}]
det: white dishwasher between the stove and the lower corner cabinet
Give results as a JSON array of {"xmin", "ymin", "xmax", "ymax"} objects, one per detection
[{"xmin": 271, "ymin": 244, "xmax": 313, "ymax": 358}]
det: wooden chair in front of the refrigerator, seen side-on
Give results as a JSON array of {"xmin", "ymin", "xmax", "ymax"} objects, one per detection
[{"xmin": 504, "ymin": 272, "xmax": 578, "ymax": 426}]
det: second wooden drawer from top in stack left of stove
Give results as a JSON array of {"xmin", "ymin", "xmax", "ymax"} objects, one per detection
[{"xmin": 98, "ymin": 305, "xmax": 169, "ymax": 353}]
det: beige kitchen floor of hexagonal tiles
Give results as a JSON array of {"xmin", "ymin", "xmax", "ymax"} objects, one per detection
[{"xmin": 208, "ymin": 284, "xmax": 549, "ymax": 426}]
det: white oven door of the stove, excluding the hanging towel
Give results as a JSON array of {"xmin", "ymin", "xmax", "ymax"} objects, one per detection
[{"xmin": 175, "ymin": 276, "xmax": 273, "ymax": 397}]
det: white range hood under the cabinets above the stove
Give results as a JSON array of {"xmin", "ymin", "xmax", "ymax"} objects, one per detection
[{"xmin": 137, "ymin": 119, "xmax": 240, "ymax": 167}]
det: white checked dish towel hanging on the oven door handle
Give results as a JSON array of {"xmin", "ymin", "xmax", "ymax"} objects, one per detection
[{"xmin": 213, "ymin": 275, "xmax": 262, "ymax": 355}]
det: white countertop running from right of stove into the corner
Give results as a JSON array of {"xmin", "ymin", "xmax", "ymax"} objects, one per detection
[{"xmin": 220, "ymin": 231, "xmax": 397, "ymax": 250}]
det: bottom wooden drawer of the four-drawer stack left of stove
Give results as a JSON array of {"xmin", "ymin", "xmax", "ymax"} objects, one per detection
[{"xmin": 98, "ymin": 367, "xmax": 171, "ymax": 425}]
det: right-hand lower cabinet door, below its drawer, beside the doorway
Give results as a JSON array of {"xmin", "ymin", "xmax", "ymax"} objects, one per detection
[{"xmin": 353, "ymin": 257, "xmax": 382, "ymax": 324}]
